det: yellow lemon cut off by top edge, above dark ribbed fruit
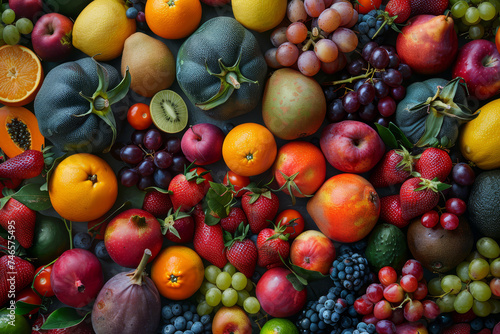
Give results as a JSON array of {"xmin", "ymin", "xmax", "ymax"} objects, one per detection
[{"xmin": 231, "ymin": 0, "xmax": 286, "ymax": 32}]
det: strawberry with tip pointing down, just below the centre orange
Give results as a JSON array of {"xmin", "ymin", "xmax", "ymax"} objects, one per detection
[{"xmin": 241, "ymin": 188, "xmax": 280, "ymax": 234}]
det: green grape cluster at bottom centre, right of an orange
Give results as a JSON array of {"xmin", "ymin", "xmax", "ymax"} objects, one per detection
[{"xmin": 197, "ymin": 263, "xmax": 260, "ymax": 315}]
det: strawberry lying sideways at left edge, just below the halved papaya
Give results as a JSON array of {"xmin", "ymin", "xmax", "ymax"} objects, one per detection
[{"xmin": 0, "ymin": 150, "xmax": 45, "ymax": 180}]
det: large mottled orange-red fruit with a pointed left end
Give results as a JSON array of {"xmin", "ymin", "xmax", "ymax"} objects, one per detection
[{"xmin": 306, "ymin": 173, "xmax": 380, "ymax": 242}]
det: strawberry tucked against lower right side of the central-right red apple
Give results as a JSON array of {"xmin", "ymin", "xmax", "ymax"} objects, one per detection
[{"xmin": 370, "ymin": 148, "xmax": 415, "ymax": 188}]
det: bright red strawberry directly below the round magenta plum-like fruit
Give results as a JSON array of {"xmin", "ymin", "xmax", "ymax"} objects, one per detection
[{"xmin": 168, "ymin": 167, "xmax": 212, "ymax": 211}]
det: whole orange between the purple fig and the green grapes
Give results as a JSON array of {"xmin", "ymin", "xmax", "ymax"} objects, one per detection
[{"xmin": 151, "ymin": 246, "xmax": 205, "ymax": 300}]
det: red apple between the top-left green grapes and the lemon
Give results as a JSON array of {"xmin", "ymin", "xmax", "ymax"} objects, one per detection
[{"xmin": 31, "ymin": 13, "xmax": 73, "ymax": 61}]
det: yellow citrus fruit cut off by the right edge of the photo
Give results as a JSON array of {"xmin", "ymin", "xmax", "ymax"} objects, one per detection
[{"xmin": 460, "ymin": 99, "xmax": 500, "ymax": 169}]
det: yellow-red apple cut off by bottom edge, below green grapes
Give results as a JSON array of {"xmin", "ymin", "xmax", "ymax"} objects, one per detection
[{"xmin": 212, "ymin": 306, "xmax": 252, "ymax": 334}]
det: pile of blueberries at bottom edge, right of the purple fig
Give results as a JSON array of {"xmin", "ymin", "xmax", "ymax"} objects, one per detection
[{"xmin": 161, "ymin": 302, "xmax": 212, "ymax": 334}]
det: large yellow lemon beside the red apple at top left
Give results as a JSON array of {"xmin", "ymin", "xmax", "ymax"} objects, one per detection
[{"xmin": 73, "ymin": 0, "xmax": 136, "ymax": 61}]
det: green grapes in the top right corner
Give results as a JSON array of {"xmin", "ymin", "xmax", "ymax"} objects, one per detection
[{"xmin": 450, "ymin": 0, "xmax": 500, "ymax": 39}]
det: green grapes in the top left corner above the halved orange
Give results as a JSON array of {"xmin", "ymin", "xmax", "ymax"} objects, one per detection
[{"xmin": 0, "ymin": 4, "xmax": 33, "ymax": 46}]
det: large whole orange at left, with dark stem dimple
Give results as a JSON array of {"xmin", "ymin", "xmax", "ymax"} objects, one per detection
[{"xmin": 49, "ymin": 153, "xmax": 118, "ymax": 222}]
